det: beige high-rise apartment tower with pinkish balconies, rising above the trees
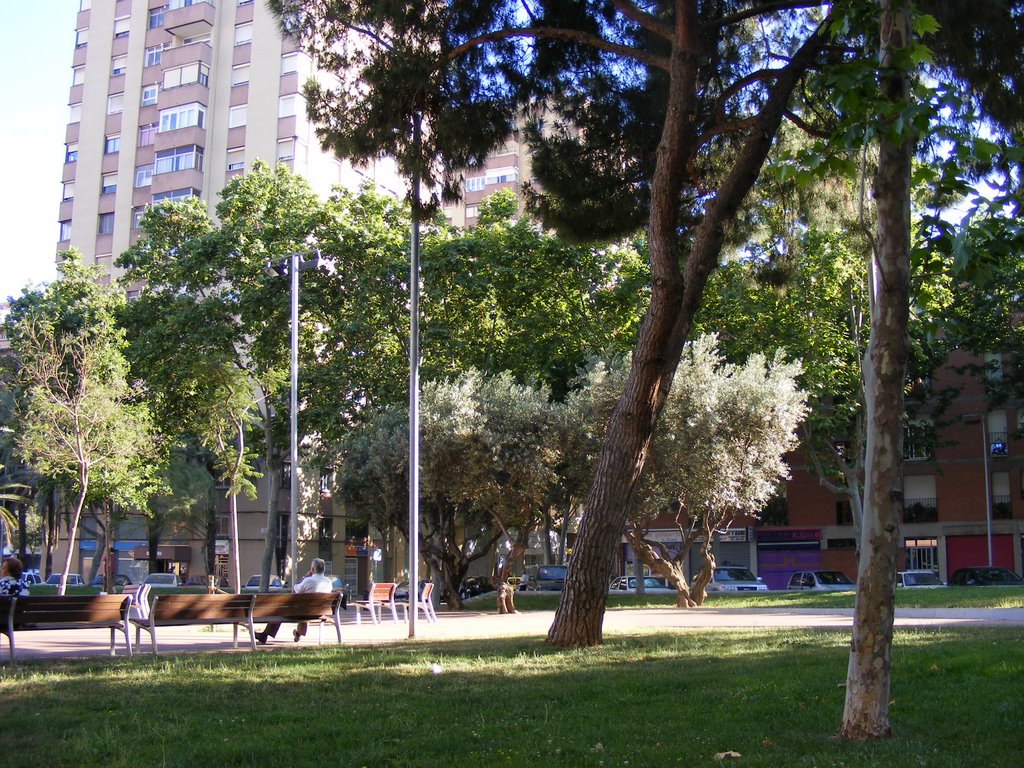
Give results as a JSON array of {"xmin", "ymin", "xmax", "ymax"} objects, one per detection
[{"xmin": 57, "ymin": 0, "xmax": 403, "ymax": 282}]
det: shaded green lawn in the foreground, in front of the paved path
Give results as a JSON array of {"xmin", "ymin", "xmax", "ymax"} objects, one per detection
[{"xmin": 0, "ymin": 628, "xmax": 1024, "ymax": 768}]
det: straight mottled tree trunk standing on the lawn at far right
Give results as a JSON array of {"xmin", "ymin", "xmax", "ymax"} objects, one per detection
[{"xmin": 842, "ymin": 0, "xmax": 913, "ymax": 740}]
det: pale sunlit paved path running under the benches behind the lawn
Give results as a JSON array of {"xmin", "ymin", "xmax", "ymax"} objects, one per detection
[{"xmin": 0, "ymin": 605, "xmax": 1024, "ymax": 665}]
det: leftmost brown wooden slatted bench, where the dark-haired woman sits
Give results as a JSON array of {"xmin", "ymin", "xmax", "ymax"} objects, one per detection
[{"xmin": 0, "ymin": 595, "xmax": 132, "ymax": 662}]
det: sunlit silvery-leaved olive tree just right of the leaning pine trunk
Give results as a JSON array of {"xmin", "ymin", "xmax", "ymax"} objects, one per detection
[{"xmin": 627, "ymin": 336, "xmax": 806, "ymax": 606}]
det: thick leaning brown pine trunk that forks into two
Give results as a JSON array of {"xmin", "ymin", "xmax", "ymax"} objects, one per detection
[{"xmin": 548, "ymin": 16, "xmax": 825, "ymax": 647}]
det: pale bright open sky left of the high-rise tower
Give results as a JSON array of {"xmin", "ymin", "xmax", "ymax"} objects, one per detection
[{"xmin": 0, "ymin": 0, "xmax": 79, "ymax": 302}]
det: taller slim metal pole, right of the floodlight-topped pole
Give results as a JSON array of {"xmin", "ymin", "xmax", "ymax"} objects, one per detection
[{"xmin": 409, "ymin": 114, "xmax": 421, "ymax": 637}]
